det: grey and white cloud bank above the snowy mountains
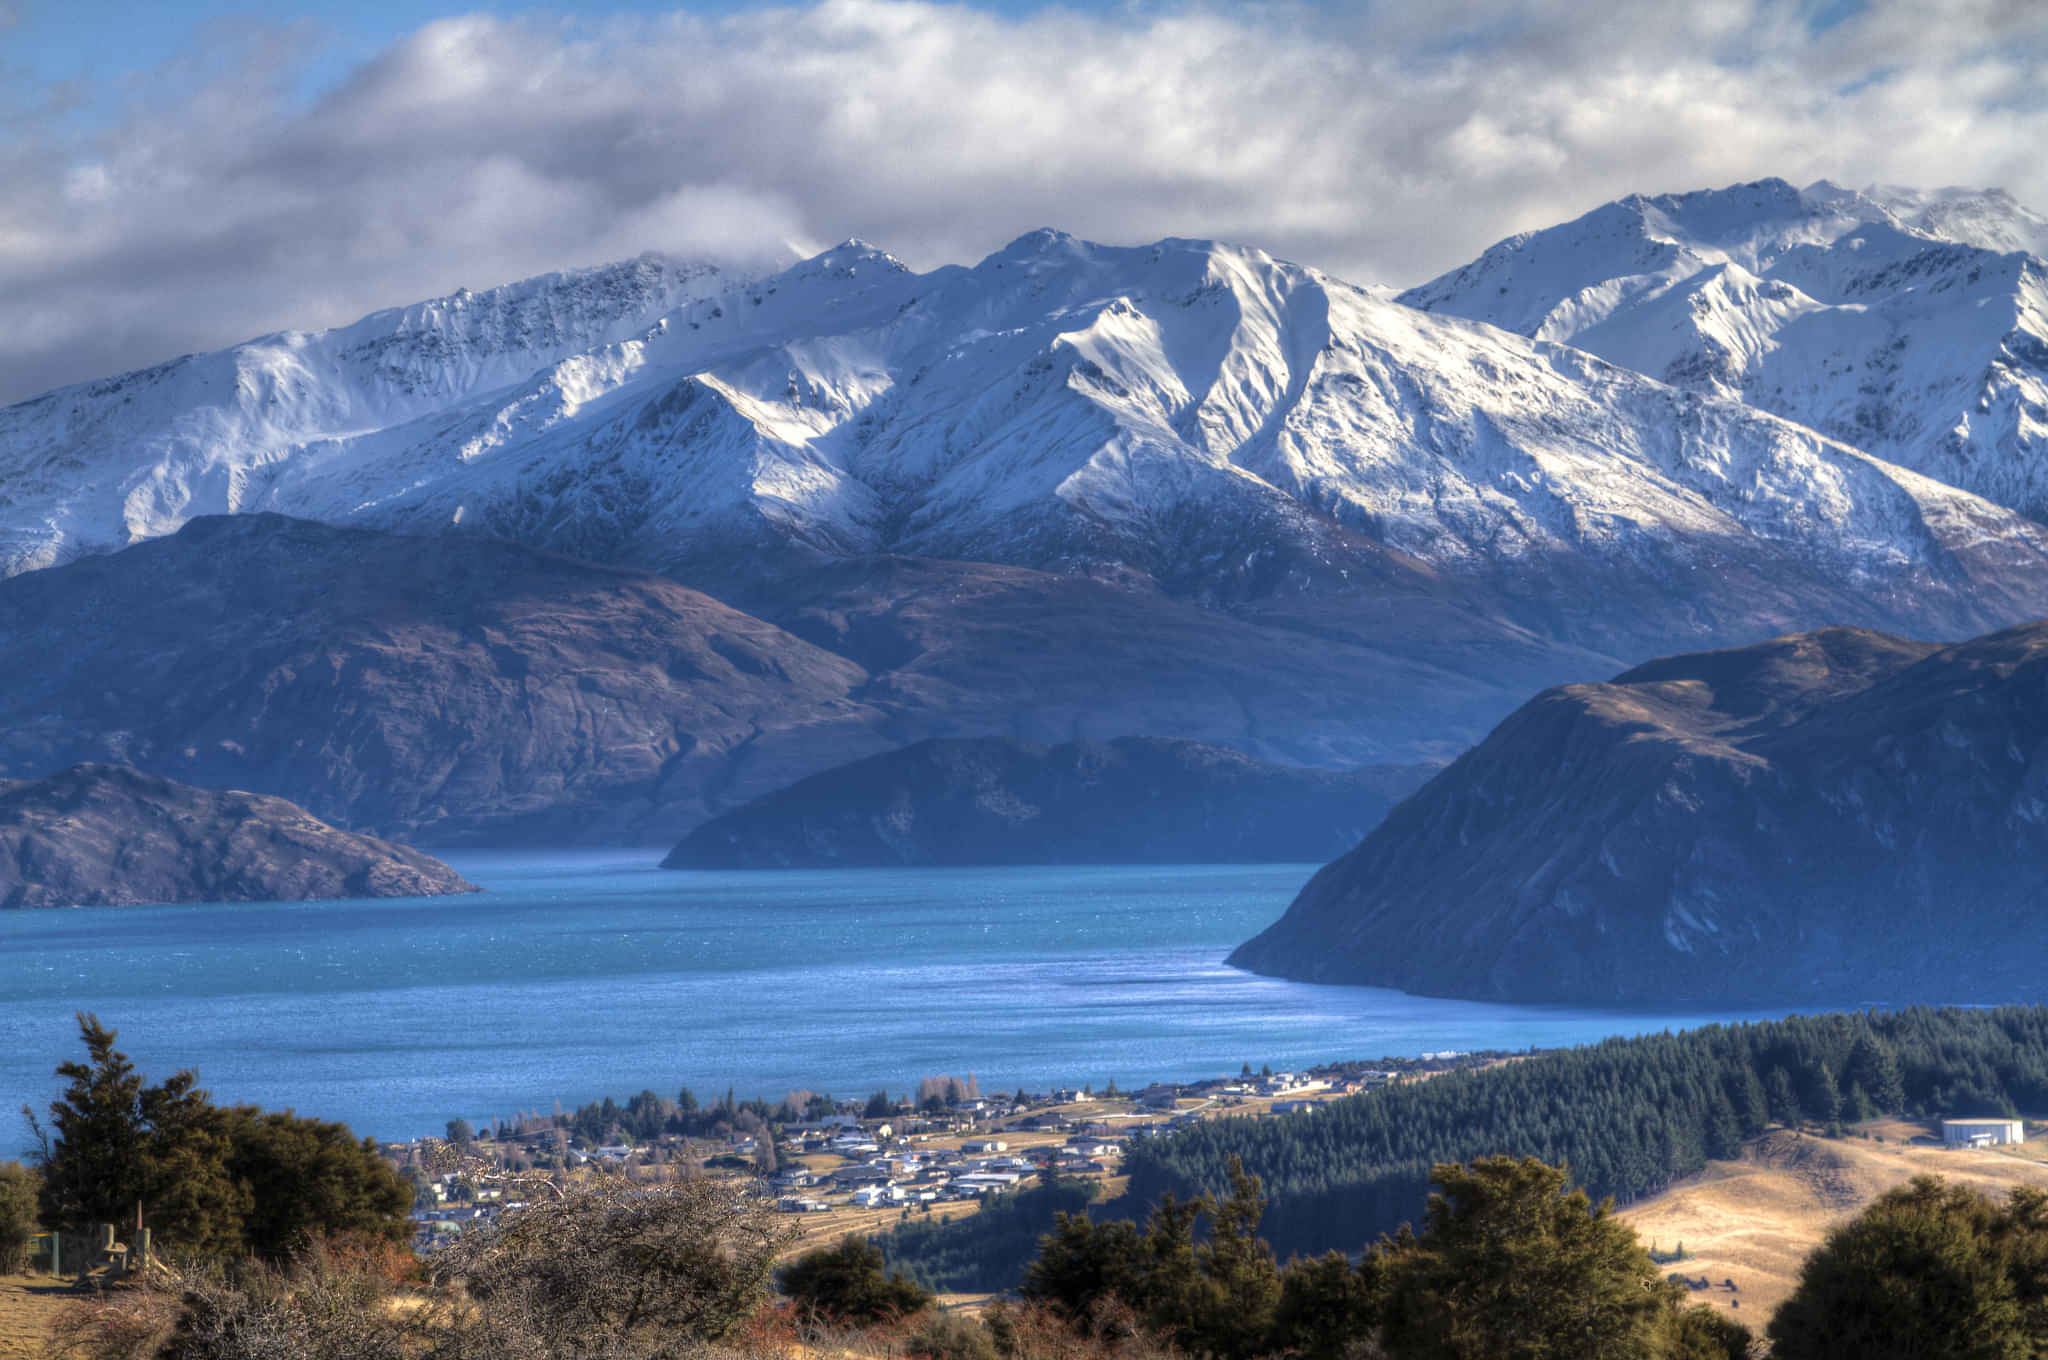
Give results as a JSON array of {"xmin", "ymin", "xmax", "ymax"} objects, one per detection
[{"xmin": 0, "ymin": 0, "xmax": 2048, "ymax": 399}]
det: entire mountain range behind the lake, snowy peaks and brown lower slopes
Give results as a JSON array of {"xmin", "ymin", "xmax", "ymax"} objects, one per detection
[{"xmin": 0, "ymin": 182, "xmax": 2048, "ymax": 842}]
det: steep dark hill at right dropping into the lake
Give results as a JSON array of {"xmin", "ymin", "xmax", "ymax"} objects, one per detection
[{"xmin": 1231, "ymin": 623, "xmax": 2048, "ymax": 1004}]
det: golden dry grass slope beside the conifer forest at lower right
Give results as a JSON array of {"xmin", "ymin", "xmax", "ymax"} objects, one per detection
[{"xmin": 1620, "ymin": 1122, "xmax": 2048, "ymax": 1331}]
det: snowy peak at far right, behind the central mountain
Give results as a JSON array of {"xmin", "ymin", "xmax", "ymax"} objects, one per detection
[{"xmin": 1401, "ymin": 180, "xmax": 2048, "ymax": 518}]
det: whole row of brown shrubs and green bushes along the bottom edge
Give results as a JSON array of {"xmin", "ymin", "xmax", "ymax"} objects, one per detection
[{"xmin": 88, "ymin": 1157, "xmax": 2048, "ymax": 1360}]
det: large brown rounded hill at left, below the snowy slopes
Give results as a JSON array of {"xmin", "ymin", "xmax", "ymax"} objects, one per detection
[{"xmin": 0, "ymin": 516, "xmax": 887, "ymax": 844}]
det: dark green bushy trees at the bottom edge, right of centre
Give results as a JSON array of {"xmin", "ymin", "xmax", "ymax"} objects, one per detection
[{"xmin": 1024, "ymin": 1157, "xmax": 1749, "ymax": 1360}]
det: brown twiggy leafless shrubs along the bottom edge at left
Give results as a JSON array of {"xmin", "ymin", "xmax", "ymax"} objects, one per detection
[{"xmin": 57, "ymin": 1180, "xmax": 786, "ymax": 1360}]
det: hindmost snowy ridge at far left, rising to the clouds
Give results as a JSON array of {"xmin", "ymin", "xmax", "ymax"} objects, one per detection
[{"xmin": 0, "ymin": 254, "xmax": 733, "ymax": 573}]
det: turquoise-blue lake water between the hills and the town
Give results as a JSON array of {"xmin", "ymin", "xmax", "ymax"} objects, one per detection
[{"xmin": 0, "ymin": 852, "xmax": 1794, "ymax": 1157}]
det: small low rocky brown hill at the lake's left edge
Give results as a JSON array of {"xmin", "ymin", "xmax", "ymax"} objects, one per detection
[{"xmin": 0, "ymin": 764, "xmax": 477, "ymax": 907}]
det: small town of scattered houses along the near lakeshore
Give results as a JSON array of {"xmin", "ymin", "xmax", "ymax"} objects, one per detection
[{"xmin": 385, "ymin": 1051, "xmax": 1474, "ymax": 1251}]
